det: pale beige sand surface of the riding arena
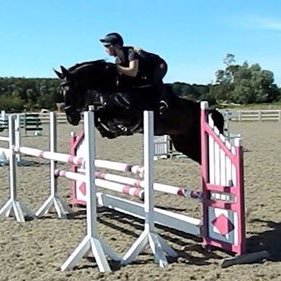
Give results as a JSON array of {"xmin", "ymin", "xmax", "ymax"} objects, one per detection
[{"xmin": 0, "ymin": 122, "xmax": 281, "ymax": 281}]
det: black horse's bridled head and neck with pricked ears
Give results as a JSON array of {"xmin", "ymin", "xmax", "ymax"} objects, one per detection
[{"xmin": 54, "ymin": 60, "xmax": 117, "ymax": 126}]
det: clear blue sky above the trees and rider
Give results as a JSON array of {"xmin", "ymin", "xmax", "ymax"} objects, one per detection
[{"xmin": 0, "ymin": 0, "xmax": 281, "ymax": 86}]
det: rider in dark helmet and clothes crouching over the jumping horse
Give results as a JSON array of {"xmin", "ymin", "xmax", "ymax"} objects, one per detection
[{"xmin": 100, "ymin": 32, "xmax": 168, "ymax": 114}]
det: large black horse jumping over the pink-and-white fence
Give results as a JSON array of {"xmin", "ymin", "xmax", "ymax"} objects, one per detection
[{"xmin": 54, "ymin": 60, "xmax": 224, "ymax": 164}]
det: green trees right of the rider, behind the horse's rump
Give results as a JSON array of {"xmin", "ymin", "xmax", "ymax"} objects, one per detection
[{"xmin": 172, "ymin": 54, "xmax": 281, "ymax": 105}]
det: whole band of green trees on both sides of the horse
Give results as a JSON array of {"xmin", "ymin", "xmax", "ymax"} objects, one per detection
[{"xmin": 0, "ymin": 54, "xmax": 281, "ymax": 111}]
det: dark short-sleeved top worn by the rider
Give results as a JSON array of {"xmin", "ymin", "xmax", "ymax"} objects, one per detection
[{"xmin": 116, "ymin": 46, "xmax": 163, "ymax": 77}]
